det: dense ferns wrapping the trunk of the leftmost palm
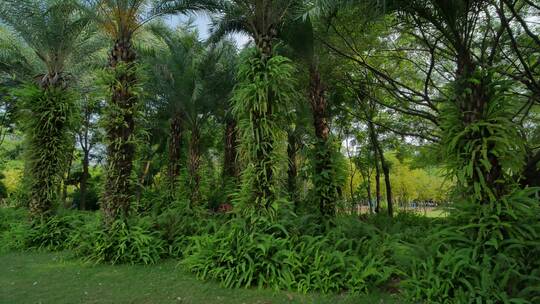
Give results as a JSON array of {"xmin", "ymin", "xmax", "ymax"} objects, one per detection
[{"xmin": 18, "ymin": 85, "xmax": 76, "ymax": 217}]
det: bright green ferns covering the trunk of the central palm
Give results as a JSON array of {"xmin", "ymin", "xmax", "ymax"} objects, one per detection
[{"xmin": 233, "ymin": 49, "xmax": 295, "ymax": 213}]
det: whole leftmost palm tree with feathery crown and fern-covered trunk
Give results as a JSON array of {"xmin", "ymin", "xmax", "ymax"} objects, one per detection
[{"xmin": 0, "ymin": 0, "xmax": 94, "ymax": 217}]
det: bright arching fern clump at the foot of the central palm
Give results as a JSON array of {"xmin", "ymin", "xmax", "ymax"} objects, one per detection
[{"xmin": 183, "ymin": 217, "xmax": 396, "ymax": 292}]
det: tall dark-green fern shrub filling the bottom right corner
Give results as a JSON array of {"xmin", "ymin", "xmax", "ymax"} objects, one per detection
[{"xmin": 404, "ymin": 189, "xmax": 540, "ymax": 303}]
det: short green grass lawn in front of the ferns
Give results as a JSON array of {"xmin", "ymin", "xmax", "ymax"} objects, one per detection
[{"xmin": 0, "ymin": 252, "xmax": 399, "ymax": 304}]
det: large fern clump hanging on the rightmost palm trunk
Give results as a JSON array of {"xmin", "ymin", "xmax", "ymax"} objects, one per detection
[{"xmin": 441, "ymin": 70, "xmax": 524, "ymax": 203}]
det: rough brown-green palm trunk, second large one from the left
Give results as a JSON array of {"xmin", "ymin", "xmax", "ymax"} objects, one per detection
[{"xmin": 102, "ymin": 37, "xmax": 137, "ymax": 225}]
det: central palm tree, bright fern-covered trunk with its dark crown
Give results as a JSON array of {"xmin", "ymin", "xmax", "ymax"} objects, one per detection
[{"xmin": 213, "ymin": 0, "xmax": 299, "ymax": 210}]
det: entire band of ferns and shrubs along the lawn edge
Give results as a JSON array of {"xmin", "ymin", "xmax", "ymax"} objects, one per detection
[{"xmin": 0, "ymin": 190, "xmax": 540, "ymax": 303}]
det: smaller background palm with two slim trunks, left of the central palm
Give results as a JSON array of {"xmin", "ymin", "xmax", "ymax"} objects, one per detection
[{"xmin": 149, "ymin": 24, "xmax": 235, "ymax": 203}]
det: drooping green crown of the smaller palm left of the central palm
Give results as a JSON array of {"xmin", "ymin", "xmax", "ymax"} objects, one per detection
[{"xmin": 144, "ymin": 23, "xmax": 236, "ymax": 125}]
